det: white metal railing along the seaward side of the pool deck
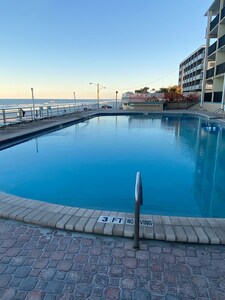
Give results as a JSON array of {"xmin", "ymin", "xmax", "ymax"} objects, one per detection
[{"xmin": 0, "ymin": 103, "xmax": 97, "ymax": 127}]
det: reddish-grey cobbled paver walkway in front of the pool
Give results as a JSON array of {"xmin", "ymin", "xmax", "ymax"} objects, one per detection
[{"xmin": 0, "ymin": 219, "xmax": 225, "ymax": 300}]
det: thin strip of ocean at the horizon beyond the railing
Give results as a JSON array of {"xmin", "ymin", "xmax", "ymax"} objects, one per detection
[{"xmin": 0, "ymin": 99, "xmax": 115, "ymax": 109}]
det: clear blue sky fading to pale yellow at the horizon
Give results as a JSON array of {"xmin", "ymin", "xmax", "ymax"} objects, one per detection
[{"xmin": 0, "ymin": 0, "xmax": 213, "ymax": 99}]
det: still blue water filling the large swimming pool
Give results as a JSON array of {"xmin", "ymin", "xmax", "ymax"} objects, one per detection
[{"xmin": 0, "ymin": 115, "xmax": 225, "ymax": 217}]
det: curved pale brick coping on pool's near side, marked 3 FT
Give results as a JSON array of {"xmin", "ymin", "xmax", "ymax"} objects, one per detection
[{"xmin": 0, "ymin": 192, "xmax": 225, "ymax": 244}]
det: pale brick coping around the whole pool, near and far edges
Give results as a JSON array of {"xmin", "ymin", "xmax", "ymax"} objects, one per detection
[{"xmin": 0, "ymin": 110, "xmax": 225, "ymax": 244}]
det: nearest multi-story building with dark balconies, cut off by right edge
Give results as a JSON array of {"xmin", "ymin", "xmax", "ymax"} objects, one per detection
[{"xmin": 201, "ymin": 0, "xmax": 225, "ymax": 111}]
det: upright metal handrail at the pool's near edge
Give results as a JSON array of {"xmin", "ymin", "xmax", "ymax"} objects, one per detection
[{"xmin": 134, "ymin": 172, "xmax": 143, "ymax": 249}]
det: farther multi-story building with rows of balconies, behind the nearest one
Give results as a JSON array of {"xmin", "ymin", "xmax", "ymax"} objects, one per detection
[{"xmin": 178, "ymin": 45, "xmax": 205, "ymax": 94}]
